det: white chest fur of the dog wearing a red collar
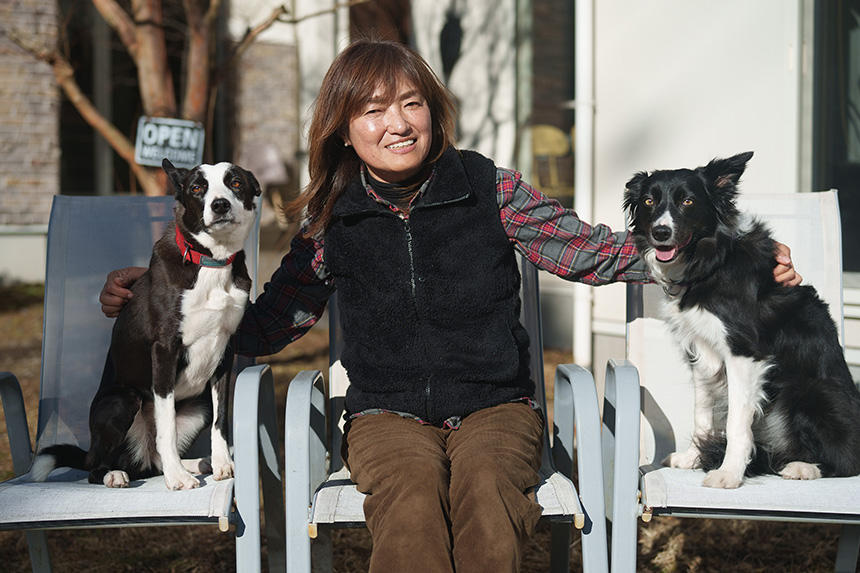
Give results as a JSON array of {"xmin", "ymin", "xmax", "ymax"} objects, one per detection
[{"xmin": 175, "ymin": 267, "xmax": 248, "ymax": 400}]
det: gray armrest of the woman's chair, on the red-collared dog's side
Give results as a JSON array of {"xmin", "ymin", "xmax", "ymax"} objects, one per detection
[{"xmin": 284, "ymin": 370, "xmax": 326, "ymax": 570}]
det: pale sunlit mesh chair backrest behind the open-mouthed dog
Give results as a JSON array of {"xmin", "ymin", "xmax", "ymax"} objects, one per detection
[{"xmin": 627, "ymin": 191, "xmax": 843, "ymax": 465}]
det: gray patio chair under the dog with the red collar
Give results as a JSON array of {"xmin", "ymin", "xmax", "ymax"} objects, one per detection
[{"xmin": 0, "ymin": 196, "xmax": 284, "ymax": 571}]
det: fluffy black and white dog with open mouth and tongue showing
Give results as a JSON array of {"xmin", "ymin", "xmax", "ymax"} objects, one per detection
[{"xmin": 624, "ymin": 152, "xmax": 860, "ymax": 488}]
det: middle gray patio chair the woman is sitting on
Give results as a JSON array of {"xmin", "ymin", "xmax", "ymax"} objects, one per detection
[{"xmin": 285, "ymin": 256, "xmax": 607, "ymax": 573}]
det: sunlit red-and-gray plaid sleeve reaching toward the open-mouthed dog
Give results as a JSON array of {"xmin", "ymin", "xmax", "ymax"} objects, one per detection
[{"xmin": 496, "ymin": 168, "xmax": 650, "ymax": 285}]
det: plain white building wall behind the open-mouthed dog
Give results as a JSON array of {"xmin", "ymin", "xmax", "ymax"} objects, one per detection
[{"xmin": 593, "ymin": 0, "xmax": 809, "ymax": 365}]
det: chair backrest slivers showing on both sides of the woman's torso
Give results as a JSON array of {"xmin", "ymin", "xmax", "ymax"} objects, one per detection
[{"xmin": 328, "ymin": 256, "xmax": 552, "ymax": 472}]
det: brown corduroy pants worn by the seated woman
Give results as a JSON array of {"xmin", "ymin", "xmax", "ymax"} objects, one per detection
[{"xmin": 345, "ymin": 403, "xmax": 543, "ymax": 573}]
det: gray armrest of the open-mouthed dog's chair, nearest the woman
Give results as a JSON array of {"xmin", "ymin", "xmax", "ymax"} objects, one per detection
[{"xmin": 603, "ymin": 360, "xmax": 640, "ymax": 567}]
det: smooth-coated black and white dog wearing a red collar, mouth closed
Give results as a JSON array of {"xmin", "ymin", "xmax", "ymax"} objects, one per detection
[{"xmin": 31, "ymin": 159, "xmax": 260, "ymax": 490}]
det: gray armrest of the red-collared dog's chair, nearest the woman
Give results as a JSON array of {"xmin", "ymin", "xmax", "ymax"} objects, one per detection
[{"xmin": 233, "ymin": 364, "xmax": 285, "ymax": 571}]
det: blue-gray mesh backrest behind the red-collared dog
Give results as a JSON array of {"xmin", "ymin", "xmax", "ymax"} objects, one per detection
[{"xmin": 36, "ymin": 195, "xmax": 259, "ymax": 449}]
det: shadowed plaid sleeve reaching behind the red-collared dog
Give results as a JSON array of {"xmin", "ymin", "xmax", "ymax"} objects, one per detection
[{"xmin": 233, "ymin": 229, "xmax": 334, "ymax": 356}]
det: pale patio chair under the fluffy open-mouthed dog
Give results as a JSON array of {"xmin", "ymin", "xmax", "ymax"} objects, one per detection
[{"xmin": 603, "ymin": 191, "xmax": 860, "ymax": 572}]
